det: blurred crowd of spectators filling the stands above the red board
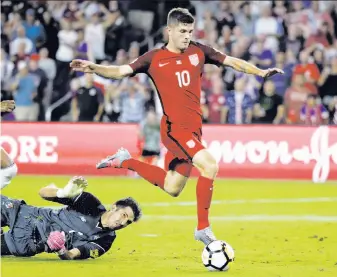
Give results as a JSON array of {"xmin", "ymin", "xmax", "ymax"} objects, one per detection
[{"xmin": 1, "ymin": 0, "xmax": 337, "ymax": 125}]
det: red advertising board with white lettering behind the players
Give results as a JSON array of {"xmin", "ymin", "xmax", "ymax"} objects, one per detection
[{"xmin": 1, "ymin": 123, "xmax": 337, "ymax": 182}]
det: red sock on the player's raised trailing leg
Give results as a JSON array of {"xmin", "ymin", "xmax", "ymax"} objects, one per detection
[{"xmin": 122, "ymin": 158, "xmax": 167, "ymax": 189}]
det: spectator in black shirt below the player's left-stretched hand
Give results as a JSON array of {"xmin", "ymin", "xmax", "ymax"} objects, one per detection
[{"xmin": 72, "ymin": 74, "xmax": 104, "ymax": 122}]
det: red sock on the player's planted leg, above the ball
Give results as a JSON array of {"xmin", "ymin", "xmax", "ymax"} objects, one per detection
[{"xmin": 197, "ymin": 176, "xmax": 214, "ymax": 230}]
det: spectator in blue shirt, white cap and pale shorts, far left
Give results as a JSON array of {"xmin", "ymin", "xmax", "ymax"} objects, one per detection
[{"xmin": 11, "ymin": 61, "xmax": 39, "ymax": 121}]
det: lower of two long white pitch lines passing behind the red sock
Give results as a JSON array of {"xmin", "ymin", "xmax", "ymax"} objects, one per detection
[{"xmin": 143, "ymin": 215, "xmax": 337, "ymax": 223}]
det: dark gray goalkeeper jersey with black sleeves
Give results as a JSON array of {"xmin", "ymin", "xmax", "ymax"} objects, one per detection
[{"xmin": 10, "ymin": 192, "xmax": 116, "ymax": 259}]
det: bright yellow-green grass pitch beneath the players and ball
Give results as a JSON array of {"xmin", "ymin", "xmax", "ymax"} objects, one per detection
[{"xmin": 1, "ymin": 176, "xmax": 337, "ymax": 277}]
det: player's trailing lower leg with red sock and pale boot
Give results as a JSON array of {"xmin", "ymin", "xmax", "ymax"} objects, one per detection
[{"xmin": 96, "ymin": 148, "xmax": 167, "ymax": 190}]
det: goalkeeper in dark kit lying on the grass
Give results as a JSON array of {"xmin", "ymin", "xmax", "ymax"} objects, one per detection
[{"xmin": 1, "ymin": 177, "xmax": 141, "ymax": 260}]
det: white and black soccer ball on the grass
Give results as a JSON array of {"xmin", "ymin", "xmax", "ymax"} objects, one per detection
[{"xmin": 201, "ymin": 240, "xmax": 234, "ymax": 271}]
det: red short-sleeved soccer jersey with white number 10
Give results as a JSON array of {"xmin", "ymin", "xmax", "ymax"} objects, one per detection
[{"xmin": 130, "ymin": 41, "xmax": 226, "ymax": 130}]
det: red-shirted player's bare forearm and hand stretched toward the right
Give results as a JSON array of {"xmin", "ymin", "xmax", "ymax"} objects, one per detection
[{"xmin": 223, "ymin": 56, "xmax": 284, "ymax": 78}]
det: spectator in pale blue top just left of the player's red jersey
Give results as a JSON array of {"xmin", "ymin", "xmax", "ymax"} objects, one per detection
[{"xmin": 117, "ymin": 78, "xmax": 149, "ymax": 123}]
